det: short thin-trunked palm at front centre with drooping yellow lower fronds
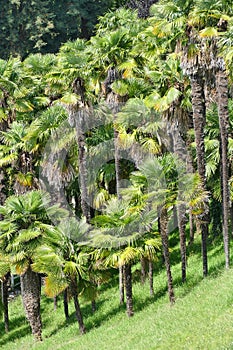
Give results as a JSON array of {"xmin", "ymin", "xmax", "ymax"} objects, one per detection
[{"xmin": 88, "ymin": 198, "xmax": 145, "ymax": 317}]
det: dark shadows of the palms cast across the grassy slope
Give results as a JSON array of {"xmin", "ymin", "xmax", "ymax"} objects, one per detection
[{"xmin": 0, "ymin": 233, "xmax": 230, "ymax": 348}]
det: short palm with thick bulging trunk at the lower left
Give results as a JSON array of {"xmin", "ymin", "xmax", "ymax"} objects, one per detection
[{"xmin": 0, "ymin": 191, "xmax": 65, "ymax": 340}]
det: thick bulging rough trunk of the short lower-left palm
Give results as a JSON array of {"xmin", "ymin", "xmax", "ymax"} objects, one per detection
[{"xmin": 20, "ymin": 265, "xmax": 42, "ymax": 341}]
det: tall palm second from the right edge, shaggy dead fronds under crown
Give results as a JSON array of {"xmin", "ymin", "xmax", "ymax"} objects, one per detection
[{"xmin": 149, "ymin": 0, "xmax": 209, "ymax": 276}]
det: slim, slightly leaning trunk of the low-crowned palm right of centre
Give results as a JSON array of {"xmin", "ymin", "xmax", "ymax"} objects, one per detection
[{"xmin": 160, "ymin": 208, "xmax": 175, "ymax": 305}]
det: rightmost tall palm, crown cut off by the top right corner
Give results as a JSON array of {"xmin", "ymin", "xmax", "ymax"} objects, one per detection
[{"xmin": 187, "ymin": 0, "xmax": 233, "ymax": 268}]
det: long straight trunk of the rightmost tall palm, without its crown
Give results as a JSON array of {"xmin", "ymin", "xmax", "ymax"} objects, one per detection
[{"xmin": 216, "ymin": 65, "xmax": 230, "ymax": 269}]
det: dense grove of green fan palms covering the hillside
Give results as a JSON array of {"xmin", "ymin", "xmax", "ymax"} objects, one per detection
[{"xmin": 0, "ymin": 0, "xmax": 233, "ymax": 340}]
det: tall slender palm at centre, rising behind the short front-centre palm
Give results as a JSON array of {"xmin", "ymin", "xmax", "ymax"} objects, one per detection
[{"xmin": 89, "ymin": 17, "xmax": 145, "ymax": 304}]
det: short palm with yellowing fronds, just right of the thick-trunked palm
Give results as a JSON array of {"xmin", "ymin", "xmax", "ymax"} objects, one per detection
[{"xmin": 33, "ymin": 218, "xmax": 89, "ymax": 334}]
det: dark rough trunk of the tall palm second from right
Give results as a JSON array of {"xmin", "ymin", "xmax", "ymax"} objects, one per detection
[{"xmin": 191, "ymin": 72, "xmax": 209, "ymax": 277}]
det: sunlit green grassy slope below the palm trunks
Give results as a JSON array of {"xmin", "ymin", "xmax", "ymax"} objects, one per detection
[{"xmin": 0, "ymin": 235, "xmax": 233, "ymax": 350}]
